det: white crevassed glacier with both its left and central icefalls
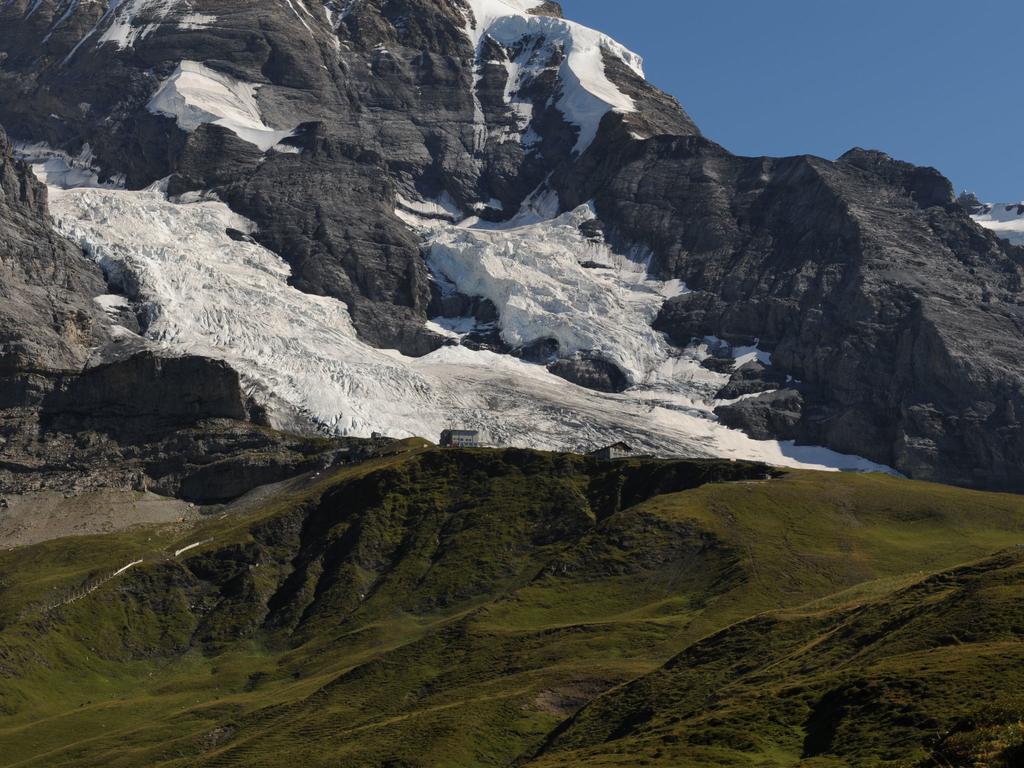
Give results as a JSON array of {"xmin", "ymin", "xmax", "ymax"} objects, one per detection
[{"xmin": 40, "ymin": 170, "xmax": 885, "ymax": 471}]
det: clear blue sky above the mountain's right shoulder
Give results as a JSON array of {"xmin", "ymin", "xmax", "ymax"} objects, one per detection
[{"xmin": 561, "ymin": 0, "xmax": 1024, "ymax": 202}]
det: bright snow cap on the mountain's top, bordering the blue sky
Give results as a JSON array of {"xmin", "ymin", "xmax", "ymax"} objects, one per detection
[{"xmin": 466, "ymin": 0, "xmax": 644, "ymax": 153}]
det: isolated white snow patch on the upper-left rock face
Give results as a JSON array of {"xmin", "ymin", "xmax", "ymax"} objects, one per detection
[{"xmin": 147, "ymin": 61, "xmax": 295, "ymax": 152}]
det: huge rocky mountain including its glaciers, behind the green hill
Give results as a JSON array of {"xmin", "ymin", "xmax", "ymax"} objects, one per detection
[{"xmin": 0, "ymin": 0, "xmax": 1024, "ymax": 490}]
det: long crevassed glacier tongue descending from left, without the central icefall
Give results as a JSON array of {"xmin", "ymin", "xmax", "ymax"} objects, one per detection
[{"xmin": 51, "ymin": 182, "xmax": 897, "ymax": 475}]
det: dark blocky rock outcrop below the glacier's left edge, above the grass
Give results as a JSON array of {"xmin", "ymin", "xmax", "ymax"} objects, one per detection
[{"xmin": 0, "ymin": 352, "xmax": 359, "ymax": 503}]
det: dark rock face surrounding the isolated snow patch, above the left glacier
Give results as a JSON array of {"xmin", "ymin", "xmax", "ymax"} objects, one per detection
[{"xmin": 0, "ymin": 0, "xmax": 679, "ymax": 354}]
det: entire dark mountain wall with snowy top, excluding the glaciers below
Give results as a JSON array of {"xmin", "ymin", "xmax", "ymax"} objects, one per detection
[{"xmin": 0, "ymin": 0, "xmax": 1024, "ymax": 489}]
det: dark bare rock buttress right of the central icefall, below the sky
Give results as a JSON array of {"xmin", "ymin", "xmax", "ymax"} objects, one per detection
[{"xmin": 558, "ymin": 137, "xmax": 1024, "ymax": 490}]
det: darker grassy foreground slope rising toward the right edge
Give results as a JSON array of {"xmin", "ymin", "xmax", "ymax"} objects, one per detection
[{"xmin": 531, "ymin": 549, "xmax": 1024, "ymax": 768}]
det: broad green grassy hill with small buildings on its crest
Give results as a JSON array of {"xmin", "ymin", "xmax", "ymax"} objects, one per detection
[{"xmin": 0, "ymin": 449, "xmax": 1024, "ymax": 768}]
